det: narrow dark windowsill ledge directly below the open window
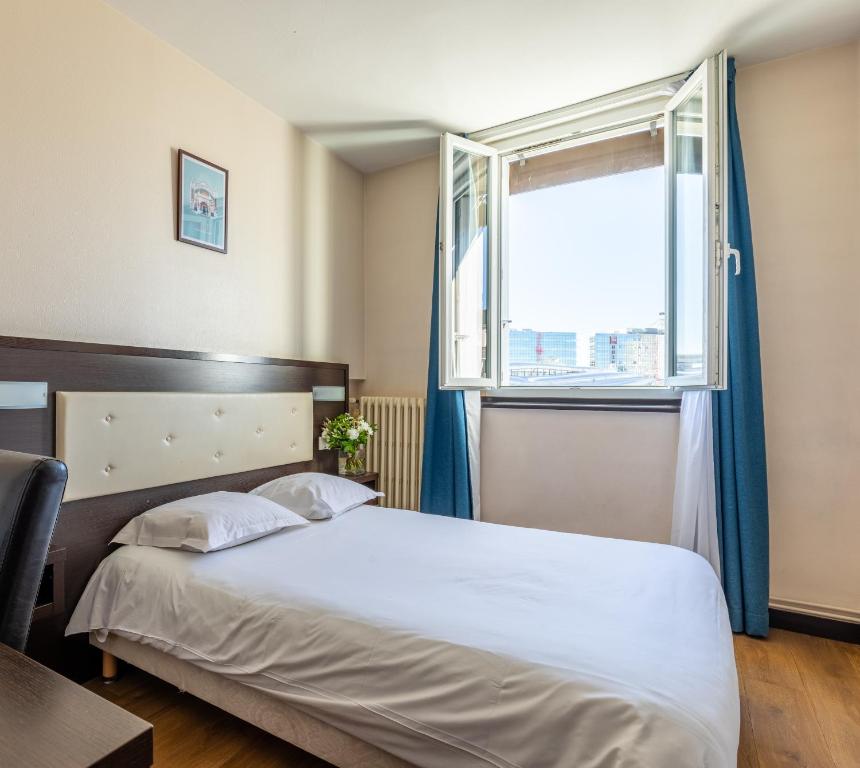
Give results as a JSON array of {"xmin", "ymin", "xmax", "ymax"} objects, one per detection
[{"xmin": 481, "ymin": 387, "xmax": 681, "ymax": 413}]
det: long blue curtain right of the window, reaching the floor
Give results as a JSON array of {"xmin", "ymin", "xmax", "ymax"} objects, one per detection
[{"xmin": 712, "ymin": 59, "xmax": 769, "ymax": 637}]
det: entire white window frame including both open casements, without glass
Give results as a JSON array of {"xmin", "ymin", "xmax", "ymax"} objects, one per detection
[{"xmin": 439, "ymin": 51, "xmax": 728, "ymax": 400}]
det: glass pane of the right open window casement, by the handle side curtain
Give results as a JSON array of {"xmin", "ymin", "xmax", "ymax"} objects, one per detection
[{"xmin": 672, "ymin": 86, "xmax": 707, "ymax": 376}]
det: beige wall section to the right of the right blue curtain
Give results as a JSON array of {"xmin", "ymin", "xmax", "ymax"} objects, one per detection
[{"xmin": 737, "ymin": 43, "xmax": 860, "ymax": 619}]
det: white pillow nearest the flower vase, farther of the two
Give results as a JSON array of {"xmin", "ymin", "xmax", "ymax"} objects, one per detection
[{"xmin": 251, "ymin": 472, "xmax": 385, "ymax": 520}]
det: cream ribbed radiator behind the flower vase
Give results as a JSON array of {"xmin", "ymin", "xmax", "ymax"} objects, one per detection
[{"xmin": 360, "ymin": 397, "xmax": 425, "ymax": 510}]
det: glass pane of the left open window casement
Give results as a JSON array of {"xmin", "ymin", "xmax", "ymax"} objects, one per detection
[{"xmin": 451, "ymin": 149, "xmax": 490, "ymax": 379}]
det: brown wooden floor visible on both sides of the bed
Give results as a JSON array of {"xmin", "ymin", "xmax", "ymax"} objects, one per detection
[{"xmin": 87, "ymin": 630, "xmax": 860, "ymax": 768}]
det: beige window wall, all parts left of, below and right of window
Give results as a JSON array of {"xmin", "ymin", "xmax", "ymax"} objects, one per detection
[{"xmin": 365, "ymin": 43, "xmax": 860, "ymax": 618}]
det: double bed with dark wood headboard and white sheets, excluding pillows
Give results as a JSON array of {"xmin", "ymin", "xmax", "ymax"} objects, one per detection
[{"xmin": 0, "ymin": 337, "xmax": 739, "ymax": 768}]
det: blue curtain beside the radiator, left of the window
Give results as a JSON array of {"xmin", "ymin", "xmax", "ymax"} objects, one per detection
[{"xmin": 420, "ymin": 210, "xmax": 472, "ymax": 519}]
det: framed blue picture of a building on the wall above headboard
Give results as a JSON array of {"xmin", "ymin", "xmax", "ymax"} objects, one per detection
[{"xmin": 176, "ymin": 149, "xmax": 227, "ymax": 253}]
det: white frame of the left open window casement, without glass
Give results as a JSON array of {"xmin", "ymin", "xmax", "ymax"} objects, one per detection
[{"xmin": 439, "ymin": 133, "xmax": 499, "ymax": 389}]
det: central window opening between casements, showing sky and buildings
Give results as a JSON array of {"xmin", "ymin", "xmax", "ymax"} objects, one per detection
[{"xmin": 503, "ymin": 128, "xmax": 666, "ymax": 387}]
